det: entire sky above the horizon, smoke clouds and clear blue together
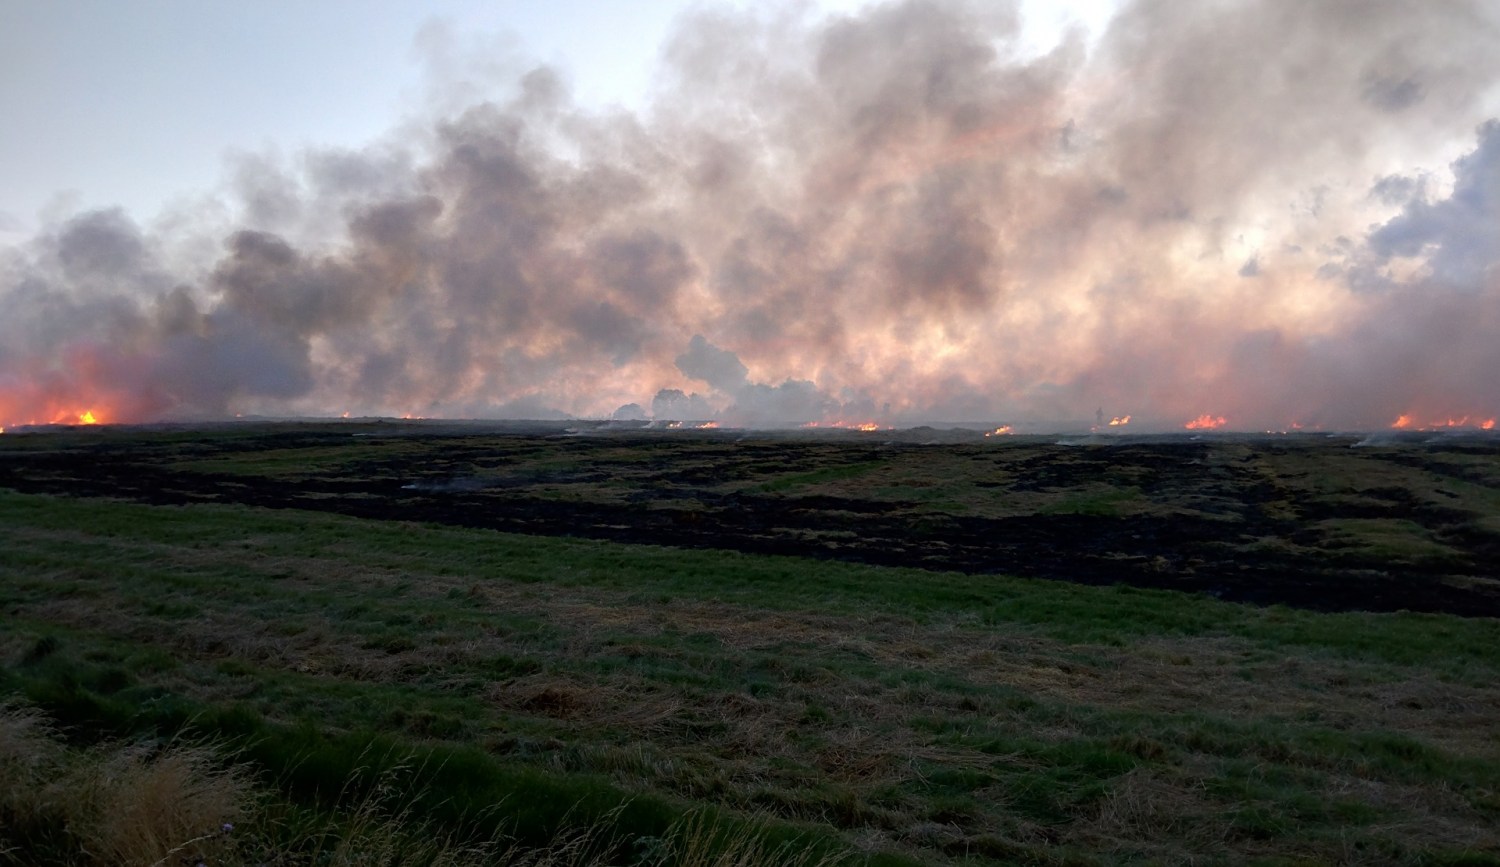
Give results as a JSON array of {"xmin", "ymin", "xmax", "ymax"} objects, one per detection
[{"xmin": 0, "ymin": 0, "xmax": 1500, "ymax": 429}]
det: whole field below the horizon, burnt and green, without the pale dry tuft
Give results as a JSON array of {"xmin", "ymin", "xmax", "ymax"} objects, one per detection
[{"xmin": 0, "ymin": 423, "xmax": 1500, "ymax": 864}]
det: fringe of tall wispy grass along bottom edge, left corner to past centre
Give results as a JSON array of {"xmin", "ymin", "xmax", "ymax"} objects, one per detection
[{"xmin": 0, "ymin": 702, "xmax": 848, "ymax": 867}]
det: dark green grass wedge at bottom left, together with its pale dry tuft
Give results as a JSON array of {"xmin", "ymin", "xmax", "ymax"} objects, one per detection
[{"xmin": 0, "ymin": 701, "xmax": 870, "ymax": 867}]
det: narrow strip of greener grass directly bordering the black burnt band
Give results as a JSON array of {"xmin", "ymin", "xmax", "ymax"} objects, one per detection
[{"xmin": 0, "ymin": 491, "xmax": 1500, "ymax": 680}]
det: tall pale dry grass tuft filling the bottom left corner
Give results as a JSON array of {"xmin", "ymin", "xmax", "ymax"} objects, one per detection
[{"xmin": 0, "ymin": 702, "xmax": 504, "ymax": 867}]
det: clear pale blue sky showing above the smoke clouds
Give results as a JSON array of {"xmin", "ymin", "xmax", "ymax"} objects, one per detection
[{"xmin": 0, "ymin": 0, "xmax": 1112, "ymax": 243}]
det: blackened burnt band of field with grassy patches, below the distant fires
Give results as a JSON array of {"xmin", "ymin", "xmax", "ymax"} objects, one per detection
[{"xmin": 0, "ymin": 426, "xmax": 1500, "ymax": 617}]
